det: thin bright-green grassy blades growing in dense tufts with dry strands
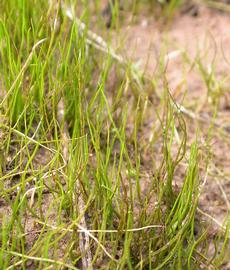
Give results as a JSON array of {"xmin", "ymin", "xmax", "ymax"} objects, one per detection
[{"xmin": 0, "ymin": 0, "xmax": 229, "ymax": 269}]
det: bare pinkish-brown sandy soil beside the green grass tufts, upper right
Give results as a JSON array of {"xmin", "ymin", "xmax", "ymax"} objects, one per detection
[{"xmin": 113, "ymin": 2, "xmax": 230, "ymax": 234}]
